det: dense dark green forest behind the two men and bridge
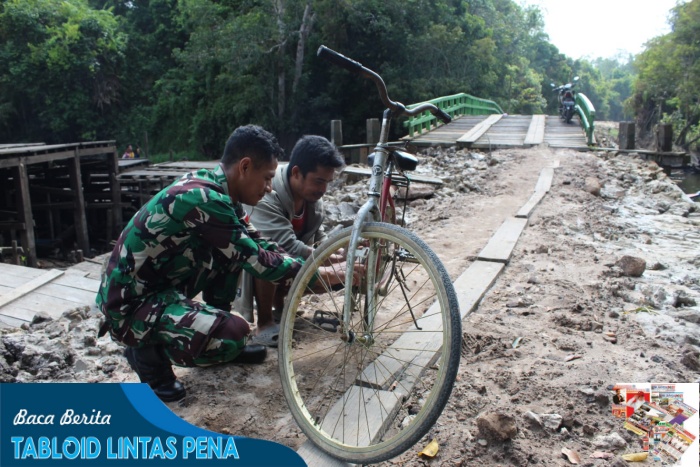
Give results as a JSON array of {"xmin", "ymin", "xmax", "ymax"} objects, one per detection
[{"xmin": 0, "ymin": 0, "xmax": 668, "ymax": 157}]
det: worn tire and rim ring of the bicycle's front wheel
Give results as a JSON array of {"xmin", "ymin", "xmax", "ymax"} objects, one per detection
[{"xmin": 279, "ymin": 223, "xmax": 462, "ymax": 464}]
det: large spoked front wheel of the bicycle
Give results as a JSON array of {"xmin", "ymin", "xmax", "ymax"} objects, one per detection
[{"xmin": 278, "ymin": 223, "xmax": 462, "ymax": 464}]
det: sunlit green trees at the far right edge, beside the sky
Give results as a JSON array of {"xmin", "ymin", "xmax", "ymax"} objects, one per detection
[{"xmin": 628, "ymin": 0, "xmax": 700, "ymax": 148}]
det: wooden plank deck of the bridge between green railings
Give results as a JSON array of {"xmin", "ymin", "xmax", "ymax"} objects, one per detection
[{"xmin": 404, "ymin": 114, "xmax": 588, "ymax": 151}]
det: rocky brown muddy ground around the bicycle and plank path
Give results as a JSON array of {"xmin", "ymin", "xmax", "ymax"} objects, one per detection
[{"xmin": 0, "ymin": 125, "xmax": 700, "ymax": 466}]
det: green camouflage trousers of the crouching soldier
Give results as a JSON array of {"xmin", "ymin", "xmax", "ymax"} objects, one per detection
[{"xmin": 121, "ymin": 290, "xmax": 250, "ymax": 367}]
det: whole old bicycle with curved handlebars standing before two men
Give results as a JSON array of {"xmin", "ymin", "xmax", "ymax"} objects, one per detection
[{"xmin": 279, "ymin": 46, "xmax": 462, "ymax": 464}]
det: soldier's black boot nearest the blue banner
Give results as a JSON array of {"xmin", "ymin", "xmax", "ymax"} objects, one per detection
[{"xmin": 124, "ymin": 345, "xmax": 185, "ymax": 402}]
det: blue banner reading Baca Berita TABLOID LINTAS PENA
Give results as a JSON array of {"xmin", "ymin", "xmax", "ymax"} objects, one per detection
[{"xmin": 0, "ymin": 383, "xmax": 306, "ymax": 467}]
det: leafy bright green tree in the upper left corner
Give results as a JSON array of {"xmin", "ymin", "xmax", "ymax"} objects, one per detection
[{"xmin": 0, "ymin": 0, "xmax": 126, "ymax": 143}]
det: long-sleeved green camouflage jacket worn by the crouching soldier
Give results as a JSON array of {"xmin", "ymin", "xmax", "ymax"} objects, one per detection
[{"xmin": 97, "ymin": 166, "xmax": 303, "ymax": 340}]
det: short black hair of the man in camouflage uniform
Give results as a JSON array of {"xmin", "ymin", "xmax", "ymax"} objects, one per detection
[{"xmin": 221, "ymin": 125, "xmax": 284, "ymax": 168}]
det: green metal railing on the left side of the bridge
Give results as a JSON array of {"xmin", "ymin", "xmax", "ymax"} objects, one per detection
[{"xmin": 403, "ymin": 93, "xmax": 503, "ymax": 137}]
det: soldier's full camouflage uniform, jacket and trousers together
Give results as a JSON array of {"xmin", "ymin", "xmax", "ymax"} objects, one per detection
[{"xmin": 96, "ymin": 166, "xmax": 303, "ymax": 366}]
